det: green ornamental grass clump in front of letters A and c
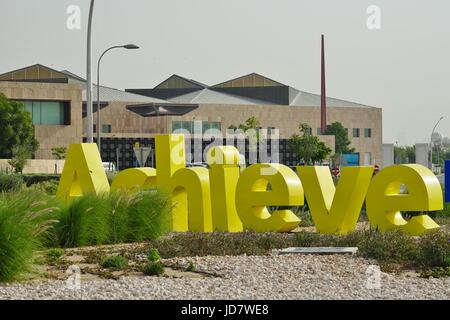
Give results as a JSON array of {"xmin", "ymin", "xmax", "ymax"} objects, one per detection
[{"xmin": 55, "ymin": 190, "xmax": 171, "ymax": 247}]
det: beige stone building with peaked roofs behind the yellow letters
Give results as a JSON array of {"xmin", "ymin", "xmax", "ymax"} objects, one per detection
[{"xmin": 0, "ymin": 65, "xmax": 382, "ymax": 167}]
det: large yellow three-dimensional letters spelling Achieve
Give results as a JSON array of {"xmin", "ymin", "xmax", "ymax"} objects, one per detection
[{"xmin": 57, "ymin": 134, "xmax": 443, "ymax": 235}]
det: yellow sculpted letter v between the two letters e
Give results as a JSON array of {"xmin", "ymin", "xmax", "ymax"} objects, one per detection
[{"xmin": 297, "ymin": 166, "xmax": 373, "ymax": 234}]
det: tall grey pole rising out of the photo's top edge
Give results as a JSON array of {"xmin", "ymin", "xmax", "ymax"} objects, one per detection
[{"xmin": 86, "ymin": 0, "xmax": 95, "ymax": 143}]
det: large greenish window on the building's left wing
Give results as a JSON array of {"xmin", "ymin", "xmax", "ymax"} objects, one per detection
[{"xmin": 24, "ymin": 101, "xmax": 70, "ymax": 125}]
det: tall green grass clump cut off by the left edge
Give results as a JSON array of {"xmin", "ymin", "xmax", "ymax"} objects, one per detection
[{"xmin": 0, "ymin": 192, "xmax": 56, "ymax": 282}]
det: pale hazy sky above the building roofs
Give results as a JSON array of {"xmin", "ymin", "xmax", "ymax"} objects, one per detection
[{"xmin": 0, "ymin": 0, "xmax": 450, "ymax": 144}]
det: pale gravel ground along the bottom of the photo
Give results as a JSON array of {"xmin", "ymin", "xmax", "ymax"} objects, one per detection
[{"xmin": 0, "ymin": 255, "xmax": 450, "ymax": 300}]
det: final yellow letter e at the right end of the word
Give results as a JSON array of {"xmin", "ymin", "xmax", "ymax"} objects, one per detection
[{"xmin": 366, "ymin": 164, "xmax": 443, "ymax": 235}]
